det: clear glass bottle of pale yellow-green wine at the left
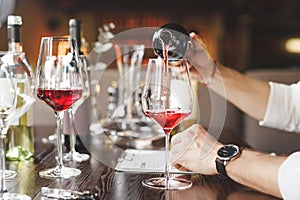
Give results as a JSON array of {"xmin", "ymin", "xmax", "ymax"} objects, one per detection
[{"xmin": 6, "ymin": 15, "xmax": 34, "ymax": 161}]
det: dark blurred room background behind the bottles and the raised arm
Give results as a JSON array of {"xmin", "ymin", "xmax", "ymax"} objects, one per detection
[{"xmin": 0, "ymin": 0, "xmax": 300, "ymax": 153}]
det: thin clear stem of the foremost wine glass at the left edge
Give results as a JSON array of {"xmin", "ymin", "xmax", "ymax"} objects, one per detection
[{"xmin": 0, "ymin": 126, "xmax": 8, "ymax": 197}]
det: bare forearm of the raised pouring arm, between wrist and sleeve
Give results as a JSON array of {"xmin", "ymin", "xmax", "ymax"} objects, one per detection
[{"xmin": 208, "ymin": 64, "xmax": 270, "ymax": 120}]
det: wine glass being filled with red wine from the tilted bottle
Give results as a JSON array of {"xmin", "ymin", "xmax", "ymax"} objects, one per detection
[{"xmin": 142, "ymin": 58, "xmax": 193, "ymax": 190}]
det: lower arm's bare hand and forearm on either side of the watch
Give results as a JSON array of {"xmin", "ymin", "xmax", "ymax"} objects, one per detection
[{"xmin": 171, "ymin": 125, "xmax": 286, "ymax": 197}]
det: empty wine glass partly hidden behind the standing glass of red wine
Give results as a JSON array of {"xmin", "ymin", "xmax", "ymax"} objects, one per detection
[{"xmin": 63, "ymin": 55, "xmax": 90, "ymax": 162}]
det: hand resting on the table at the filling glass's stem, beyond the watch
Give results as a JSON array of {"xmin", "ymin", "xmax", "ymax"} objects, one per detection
[{"xmin": 170, "ymin": 124, "xmax": 222, "ymax": 175}]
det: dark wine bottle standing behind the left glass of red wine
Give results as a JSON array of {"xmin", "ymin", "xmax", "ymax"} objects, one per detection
[{"xmin": 63, "ymin": 19, "xmax": 91, "ymax": 152}]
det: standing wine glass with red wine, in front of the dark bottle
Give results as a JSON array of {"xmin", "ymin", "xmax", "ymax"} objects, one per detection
[{"xmin": 36, "ymin": 36, "xmax": 83, "ymax": 179}]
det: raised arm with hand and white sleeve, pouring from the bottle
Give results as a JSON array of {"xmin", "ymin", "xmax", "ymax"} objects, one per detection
[{"xmin": 187, "ymin": 33, "xmax": 300, "ymax": 132}]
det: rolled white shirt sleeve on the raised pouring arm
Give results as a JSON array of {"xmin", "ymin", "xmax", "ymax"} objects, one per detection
[{"xmin": 259, "ymin": 81, "xmax": 300, "ymax": 132}]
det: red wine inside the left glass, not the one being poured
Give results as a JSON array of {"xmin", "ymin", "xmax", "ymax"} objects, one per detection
[{"xmin": 37, "ymin": 88, "xmax": 82, "ymax": 112}]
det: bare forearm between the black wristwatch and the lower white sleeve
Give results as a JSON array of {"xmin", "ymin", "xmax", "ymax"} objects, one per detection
[{"xmin": 226, "ymin": 149, "xmax": 286, "ymax": 198}]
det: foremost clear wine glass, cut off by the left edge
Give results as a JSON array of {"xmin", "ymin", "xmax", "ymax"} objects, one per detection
[{"xmin": 0, "ymin": 53, "xmax": 35, "ymax": 200}]
